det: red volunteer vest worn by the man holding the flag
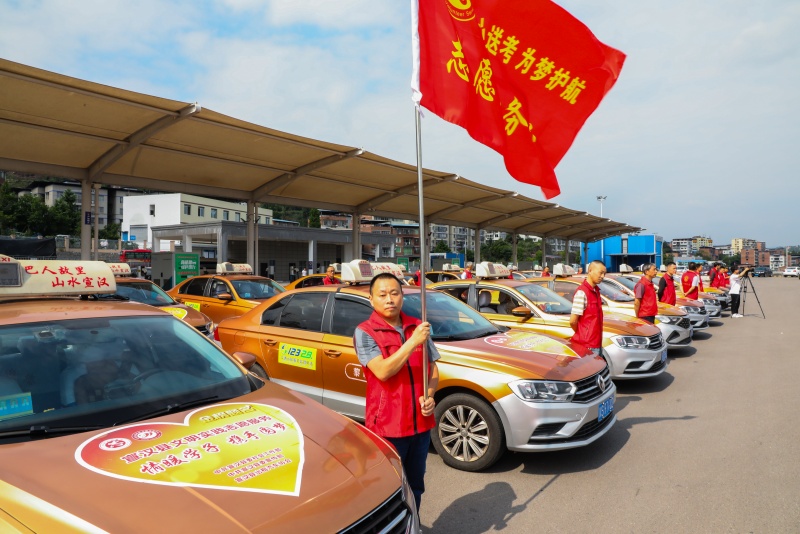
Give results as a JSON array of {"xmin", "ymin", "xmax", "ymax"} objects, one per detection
[{"xmin": 358, "ymin": 312, "xmax": 436, "ymax": 438}]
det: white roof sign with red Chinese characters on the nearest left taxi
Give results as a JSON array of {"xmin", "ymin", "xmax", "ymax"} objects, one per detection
[{"xmin": 0, "ymin": 256, "xmax": 117, "ymax": 297}]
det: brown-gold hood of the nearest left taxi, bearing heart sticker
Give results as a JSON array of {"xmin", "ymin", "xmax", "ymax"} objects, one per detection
[{"xmin": 0, "ymin": 384, "xmax": 401, "ymax": 532}]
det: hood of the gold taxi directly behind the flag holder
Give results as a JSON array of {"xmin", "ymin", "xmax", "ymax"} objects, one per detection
[{"xmin": 436, "ymin": 329, "xmax": 606, "ymax": 386}]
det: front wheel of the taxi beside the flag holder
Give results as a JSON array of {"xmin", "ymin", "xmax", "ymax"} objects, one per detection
[{"xmin": 431, "ymin": 393, "xmax": 506, "ymax": 471}]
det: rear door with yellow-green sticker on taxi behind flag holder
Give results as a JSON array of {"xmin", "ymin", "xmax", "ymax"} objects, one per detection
[{"xmin": 253, "ymin": 292, "xmax": 328, "ymax": 403}]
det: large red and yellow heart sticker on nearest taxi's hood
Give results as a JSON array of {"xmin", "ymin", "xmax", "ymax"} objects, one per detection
[{"xmin": 75, "ymin": 403, "xmax": 305, "ymax": 497}]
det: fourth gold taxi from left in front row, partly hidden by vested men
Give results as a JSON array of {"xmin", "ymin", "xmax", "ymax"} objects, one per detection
[{"xmin": 530, "ymin": 272, "xmax": 693, "ymax": 347}]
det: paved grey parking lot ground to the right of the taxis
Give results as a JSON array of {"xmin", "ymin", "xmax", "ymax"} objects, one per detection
[{"xmin": 421, "ymin": 278, "xmax": 800, "ymax": 534}]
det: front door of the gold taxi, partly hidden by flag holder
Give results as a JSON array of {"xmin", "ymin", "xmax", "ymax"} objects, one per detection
[{"xmin": 320, "ymin": 293, "xmax": 372, "ymax": 421}]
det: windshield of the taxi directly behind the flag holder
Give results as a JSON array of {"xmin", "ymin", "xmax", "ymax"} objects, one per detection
[{"xmin": 403, "ymin": 291, "xmax": 498, "ymax": 341}]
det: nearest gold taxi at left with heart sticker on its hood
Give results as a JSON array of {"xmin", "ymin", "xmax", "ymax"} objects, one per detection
[{"xmin": 0, "ymin": 258, "xmax": 418, "ymax": 533}]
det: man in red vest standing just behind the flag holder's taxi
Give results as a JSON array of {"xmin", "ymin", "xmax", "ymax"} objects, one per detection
[{"xmin": 569, "ymin": 260, "xmax": 606, "ymax": 355}]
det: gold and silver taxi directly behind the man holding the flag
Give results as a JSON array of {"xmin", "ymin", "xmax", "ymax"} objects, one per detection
[{"xmin": 214, "ymin": 260, "xmax": 616, "ymax": 471}]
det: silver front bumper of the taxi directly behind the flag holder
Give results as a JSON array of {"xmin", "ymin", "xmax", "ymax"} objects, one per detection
[{"xmin": 493, "ymin": 381, "xmax": 617, "ymax": 452}]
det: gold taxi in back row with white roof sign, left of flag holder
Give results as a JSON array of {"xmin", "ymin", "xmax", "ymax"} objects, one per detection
[{"xmin": 167, "ymin": 262, "xmax": 286, "ymax": 323}]
